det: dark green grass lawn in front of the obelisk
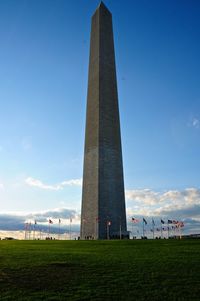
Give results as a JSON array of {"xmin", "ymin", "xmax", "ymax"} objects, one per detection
[{"xmin": 0, "ymin": 240, "xmax": 200, "ymax": 301}]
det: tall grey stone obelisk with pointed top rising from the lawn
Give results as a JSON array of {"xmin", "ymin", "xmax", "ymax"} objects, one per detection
[{"xmin": 80, "ymin": 2, "xmax": 128, "ymax": 239}]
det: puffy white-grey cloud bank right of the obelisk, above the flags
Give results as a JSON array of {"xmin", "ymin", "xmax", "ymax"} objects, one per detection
[{"xmin": 126, "ymin": 188, "xmax": 200, "ymax": 217}]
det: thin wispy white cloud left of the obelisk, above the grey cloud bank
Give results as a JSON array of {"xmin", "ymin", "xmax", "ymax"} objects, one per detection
[{"xmin": 25, "ymin": 177, "xmax": 82, "ymax": 190}]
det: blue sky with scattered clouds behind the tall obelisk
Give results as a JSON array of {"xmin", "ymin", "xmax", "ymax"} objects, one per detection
[{"xmin": 0, "ymin": 0, "xmax": 200, "ymax": 232}]
